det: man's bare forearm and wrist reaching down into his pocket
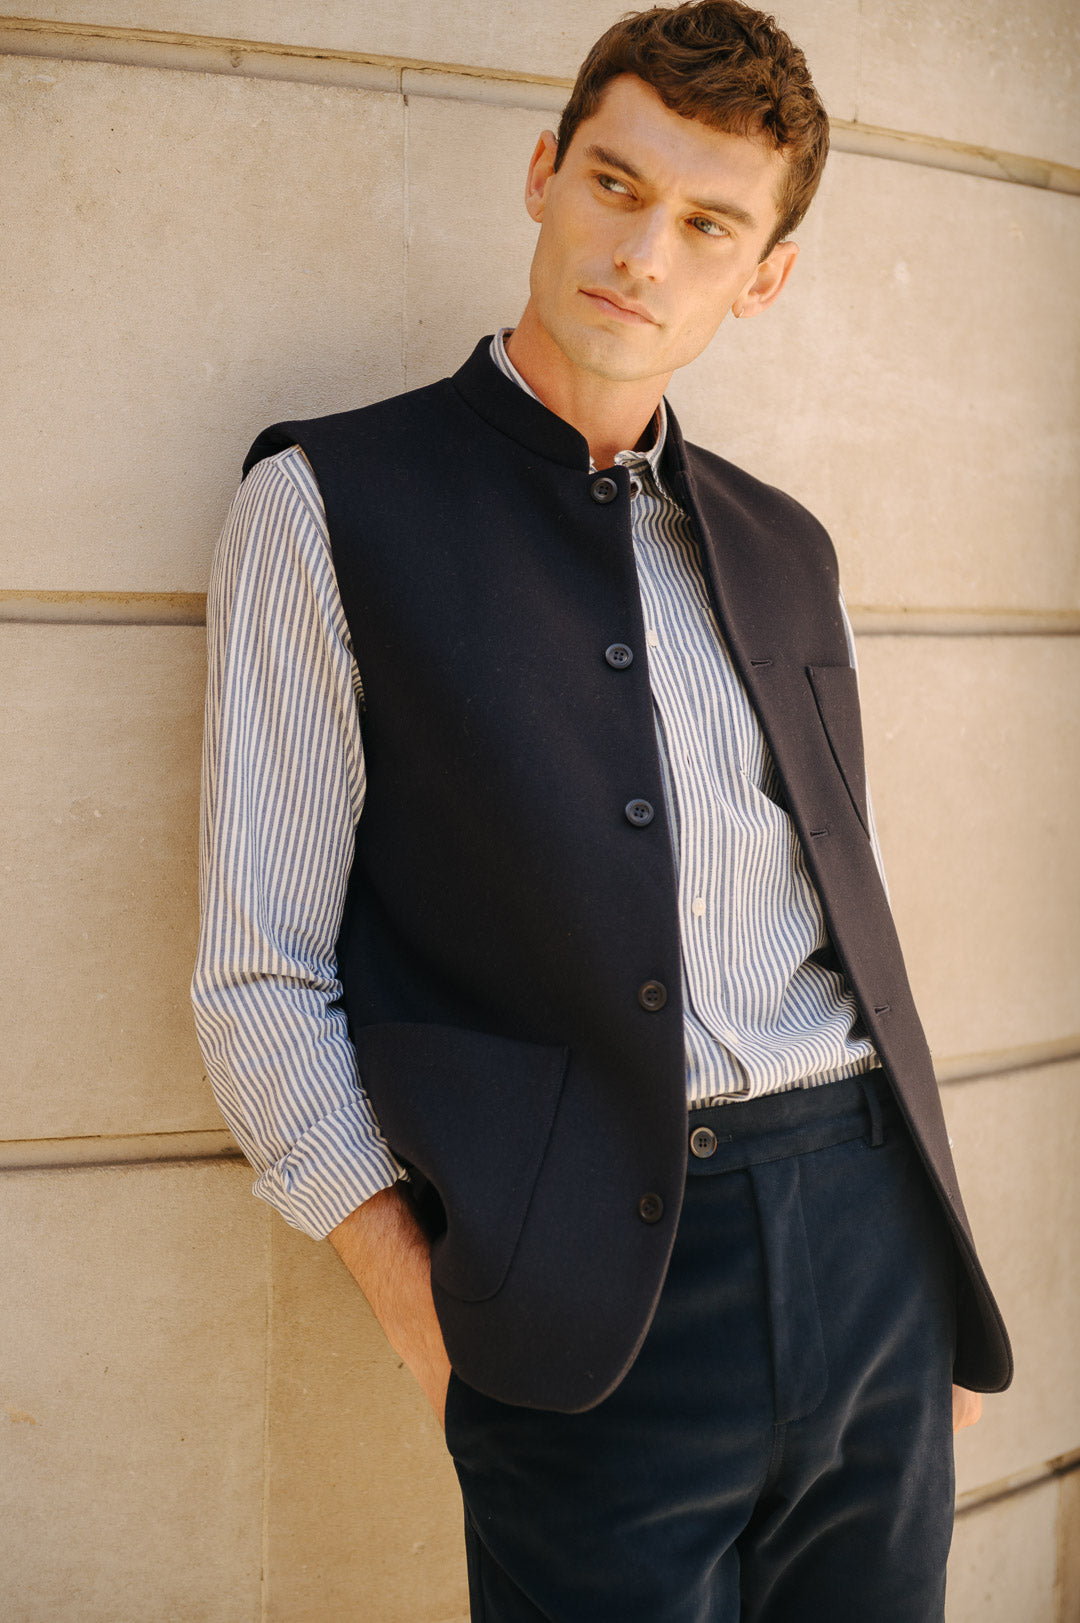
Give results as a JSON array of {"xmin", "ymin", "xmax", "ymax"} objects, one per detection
[{"xmin": 328, "ymin": 1186, "xmax": 450, "ymax": 1425}]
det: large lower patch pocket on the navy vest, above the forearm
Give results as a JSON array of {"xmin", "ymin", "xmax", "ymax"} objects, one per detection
[{"xmin": 352, "ymin": 1024, "xmax": 568, "ymax": 1302}]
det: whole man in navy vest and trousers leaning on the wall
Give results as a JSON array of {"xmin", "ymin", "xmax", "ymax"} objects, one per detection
[{"xmin": 195, "ymin": 0, "xmax": 1010, "ymax": 1623}]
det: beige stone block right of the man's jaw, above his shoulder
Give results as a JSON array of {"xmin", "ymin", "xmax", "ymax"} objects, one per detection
[{"xmin": 669, "ymin": 153, "xmax": 1080, "ymax": 609}]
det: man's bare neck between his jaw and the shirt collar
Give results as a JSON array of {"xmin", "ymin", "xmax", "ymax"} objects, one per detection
[{"xmin": 507, "ymin": 305, "xmax": 667, "ymax": 467}]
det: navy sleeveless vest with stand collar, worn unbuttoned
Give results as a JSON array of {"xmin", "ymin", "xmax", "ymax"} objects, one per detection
[{"xmin": 245, "ymin": 339, "xmax": 1010, "ymax": 1410}]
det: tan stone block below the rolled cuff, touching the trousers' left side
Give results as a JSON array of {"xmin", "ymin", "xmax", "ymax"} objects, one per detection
[{"xmin": 265, "ymin": 1222, "xmax": 468, "ymax": 1623}]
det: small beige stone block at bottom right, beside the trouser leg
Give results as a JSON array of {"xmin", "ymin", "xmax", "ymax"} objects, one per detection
[{"xmin": 945, "ymin": 1482, "xmax": 1069, "ymax": 1623}]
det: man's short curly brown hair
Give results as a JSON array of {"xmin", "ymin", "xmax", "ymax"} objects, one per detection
[{"xmin": 555, "ymin": 0, "xmax": 828, "ymax": 256}]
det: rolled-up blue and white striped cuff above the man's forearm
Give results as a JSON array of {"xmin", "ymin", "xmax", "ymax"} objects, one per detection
[{"xmin": 253, "ymin": 1094, "xmax": 404, "ymax": 1240}]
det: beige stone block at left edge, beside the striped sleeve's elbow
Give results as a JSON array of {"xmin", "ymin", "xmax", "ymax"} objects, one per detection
[{"xmin": 0, "ymin": 625, "xmax": 221, "ymax": 1138}]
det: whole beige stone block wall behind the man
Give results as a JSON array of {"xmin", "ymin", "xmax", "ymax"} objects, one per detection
[{"xmin": 0, "ymin": 0, "xmax": 1080, "ymax": 1623}]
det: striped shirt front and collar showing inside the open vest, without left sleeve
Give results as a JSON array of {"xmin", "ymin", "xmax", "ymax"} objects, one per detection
[{"xmin": 492, "ymin": 328, "xmax": 880, "ymax": 1105}]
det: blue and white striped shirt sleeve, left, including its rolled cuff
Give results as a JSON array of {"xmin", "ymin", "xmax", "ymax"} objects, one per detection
[{"xmin": 192, "ymin": 446, "xmax": 403, "ymax": 1238}]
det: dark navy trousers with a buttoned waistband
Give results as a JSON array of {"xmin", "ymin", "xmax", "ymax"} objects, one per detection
[{"xmin": 447, "ymin": 1073, "xmax": 955, "ymax": 1623}]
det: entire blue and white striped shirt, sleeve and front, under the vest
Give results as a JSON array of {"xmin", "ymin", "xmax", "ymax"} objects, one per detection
[{"xmin": 192, "ymin": 333, "xmax": 877, "ymax": 1237}]
